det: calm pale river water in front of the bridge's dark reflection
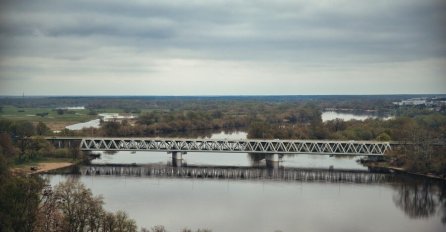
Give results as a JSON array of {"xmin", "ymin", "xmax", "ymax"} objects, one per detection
[{"xmin": 46, "ymin": 175, "xmax": 446, "ymax": 232}]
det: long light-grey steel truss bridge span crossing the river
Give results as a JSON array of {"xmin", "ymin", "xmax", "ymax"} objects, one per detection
[{"xmin": 46, "ymin": 137, "xmax": 391, "ymax": 156}]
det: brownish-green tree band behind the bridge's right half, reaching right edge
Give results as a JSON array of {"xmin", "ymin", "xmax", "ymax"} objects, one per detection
[{"xmin": 248, "ymin": 112, "xmax": 446, "ymax": 141}]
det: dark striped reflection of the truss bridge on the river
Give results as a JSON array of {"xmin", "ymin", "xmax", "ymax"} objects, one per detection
[{"xmin": 77, "ymin": 165, "xmax": 393, "ymax": 184}]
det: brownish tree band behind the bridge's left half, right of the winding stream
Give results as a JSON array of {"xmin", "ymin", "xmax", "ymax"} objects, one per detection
[{"xmin": 64, "ymin": 104, "xmax": 321, "ymax": 137}]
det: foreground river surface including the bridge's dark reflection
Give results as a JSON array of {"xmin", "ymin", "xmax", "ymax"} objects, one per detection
[{"xmin": 45, "ymin": 165, "xmax": 446, "ymax": 231}]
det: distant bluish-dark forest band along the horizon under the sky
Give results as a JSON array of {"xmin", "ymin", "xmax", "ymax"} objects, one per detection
[{"xmin": 0, "ymin": 95, "xmax": 412, "ymax": 111}]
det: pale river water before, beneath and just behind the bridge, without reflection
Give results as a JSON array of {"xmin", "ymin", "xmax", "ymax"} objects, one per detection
[{"xmin": 47, "ymin": 132, "xmax": 446, "ymax": 231}]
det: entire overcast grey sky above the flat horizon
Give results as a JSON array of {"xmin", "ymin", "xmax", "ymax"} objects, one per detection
[{"xmin": 0, "ymin": 0, "xmax": 446, "ymax": 95}]
